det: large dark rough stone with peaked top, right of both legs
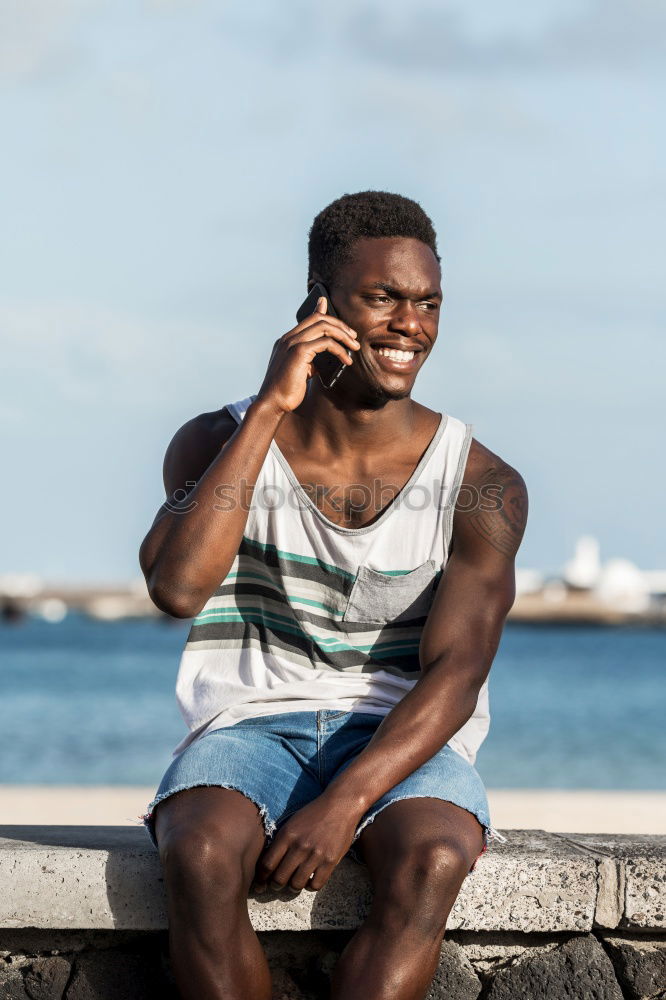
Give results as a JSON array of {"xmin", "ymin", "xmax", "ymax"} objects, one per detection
[{"xmin": 487, "ymin": 935, "xmax": 623, "ymax": 1000}]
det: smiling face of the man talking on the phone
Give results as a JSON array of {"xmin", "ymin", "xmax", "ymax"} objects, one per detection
[{"xmin": 310, "ymin": 237, "xmax": 442, "ymax": 406}]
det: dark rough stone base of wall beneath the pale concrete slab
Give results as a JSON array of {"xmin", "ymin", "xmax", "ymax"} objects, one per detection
[{"xmin": 5, "ymin": 930, "xmax": 666, "ymax": 1000}]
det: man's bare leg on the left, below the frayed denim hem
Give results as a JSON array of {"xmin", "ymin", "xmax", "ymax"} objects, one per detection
[{"xmin": 155, "ymin": 787, "xmax": 270, "ymax": 1000}]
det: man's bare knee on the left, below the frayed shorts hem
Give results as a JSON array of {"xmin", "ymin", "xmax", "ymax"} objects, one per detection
[{"xmin": 159, "ymin": 823, "xmax": 252, "ymax": 899}]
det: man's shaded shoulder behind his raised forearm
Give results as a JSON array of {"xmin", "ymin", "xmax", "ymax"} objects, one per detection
[{"xmin": 163, "ymin": 407, "xmax": 238, "ymax": 497}]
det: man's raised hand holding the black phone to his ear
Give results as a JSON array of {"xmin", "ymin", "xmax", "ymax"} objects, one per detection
[{"xmin": 257, "ymin": 295, "xmax": 360, "ymax": 413}]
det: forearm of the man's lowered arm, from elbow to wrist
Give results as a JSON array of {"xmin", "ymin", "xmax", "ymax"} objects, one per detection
[{"xmin": 324, "ymin": 660, "xmax": 481, "ymax": 818}]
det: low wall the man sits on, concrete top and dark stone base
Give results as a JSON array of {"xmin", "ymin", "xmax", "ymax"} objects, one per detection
[{"xmin": 0, "ymin": 827, "xmax": 666, "ymax": 1000}]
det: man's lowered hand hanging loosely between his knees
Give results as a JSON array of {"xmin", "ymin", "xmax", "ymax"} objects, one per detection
[{"xmin": 253, "ymin": 795, "xmax": 360, "ymax": 893}]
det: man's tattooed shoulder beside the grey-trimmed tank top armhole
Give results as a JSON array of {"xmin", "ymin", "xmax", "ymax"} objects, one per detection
[{"xmin": 453, "ymin": 438, "xmax": 528, "ymax": 558}]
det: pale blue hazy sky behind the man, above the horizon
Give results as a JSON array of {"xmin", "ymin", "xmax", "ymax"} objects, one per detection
[{"xmin": 0, "ymin": 0, "xmax": 666, "ymax": 582}]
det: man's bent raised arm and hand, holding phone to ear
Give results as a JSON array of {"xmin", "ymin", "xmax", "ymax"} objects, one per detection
[{"xmin": 139, "ymin": 298, "xmax": 358, "ymax": 618}]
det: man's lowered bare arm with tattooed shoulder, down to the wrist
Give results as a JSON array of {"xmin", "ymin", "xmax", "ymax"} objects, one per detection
[{"xmin": 323, "ymin": 442, "xmax": 527, "ymax": 816}]
